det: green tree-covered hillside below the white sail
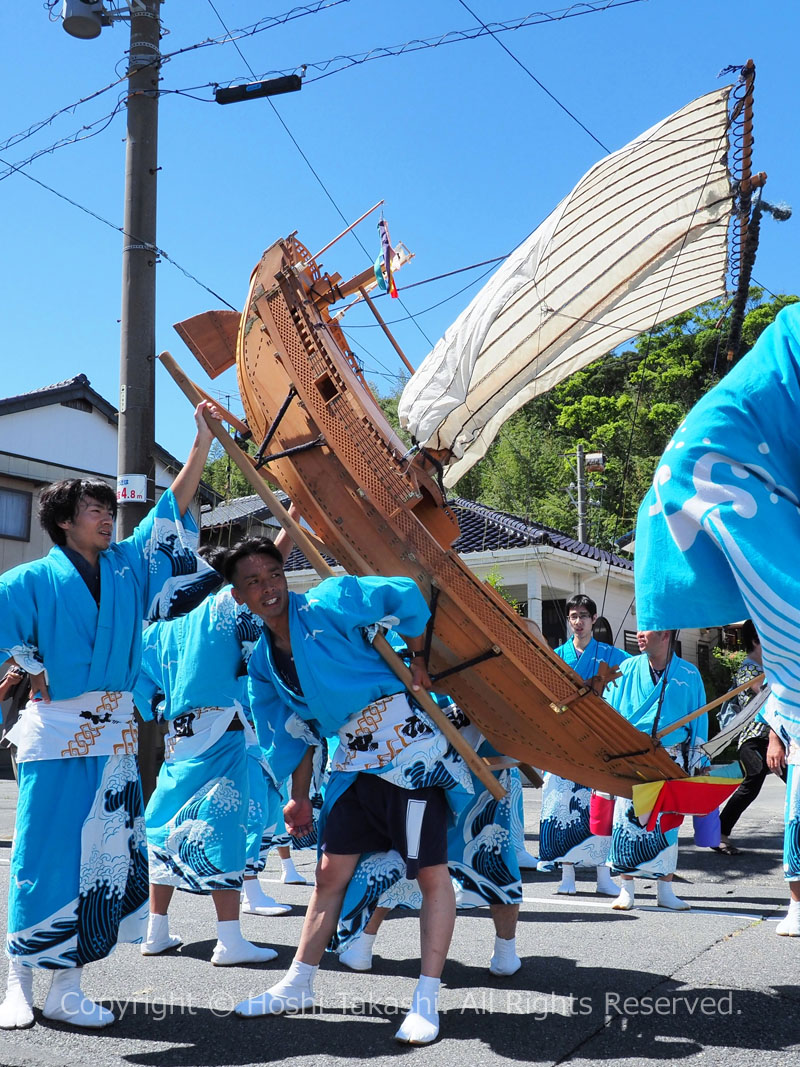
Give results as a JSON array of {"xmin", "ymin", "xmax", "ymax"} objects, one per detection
[{"xmin": 457, "ymin": 288, "xmax": 798, "ymax": 546}]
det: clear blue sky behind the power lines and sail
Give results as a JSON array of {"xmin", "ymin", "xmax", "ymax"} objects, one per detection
[{"xmin": 0, "ymin": 0, "xmax": 800, "ymax": 457}]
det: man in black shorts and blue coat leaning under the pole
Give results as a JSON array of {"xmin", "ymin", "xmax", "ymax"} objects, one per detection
[{"xmin": 226, "ymin": 541, "xmax": 469, "ymax": 1045}]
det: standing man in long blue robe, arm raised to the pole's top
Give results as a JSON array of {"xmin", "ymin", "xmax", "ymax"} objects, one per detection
[{"xmin": 0, "ymin": 402, "xmax": 219, "ymax": 1030}]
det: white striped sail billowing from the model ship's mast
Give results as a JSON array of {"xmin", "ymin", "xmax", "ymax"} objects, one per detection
[{"xmin": 398, "ymin": 86, "xmax": 733, "ymax": 485}]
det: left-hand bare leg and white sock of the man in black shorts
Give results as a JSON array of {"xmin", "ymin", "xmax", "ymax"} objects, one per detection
[{"xmin": 235, "ymin": 853, "xmax": 358, "ymax": 1018}]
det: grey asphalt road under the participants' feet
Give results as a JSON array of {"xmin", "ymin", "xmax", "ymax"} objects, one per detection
[{"xmin": 0, "ymin": 778, "xmax": 800, "ymax": 1067}]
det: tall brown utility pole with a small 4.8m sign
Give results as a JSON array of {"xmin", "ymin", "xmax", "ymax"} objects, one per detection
[{"xmin": 117, "ymin": 0, "xmax": 161, "ymax": 540}]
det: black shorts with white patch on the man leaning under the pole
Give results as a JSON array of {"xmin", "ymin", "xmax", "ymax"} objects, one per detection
[{"xmin": 322, "ymin": 774, "xmax": 448, "ymax": 878}]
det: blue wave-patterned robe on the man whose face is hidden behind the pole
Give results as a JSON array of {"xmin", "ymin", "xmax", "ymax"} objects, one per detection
[{"xmin": 135, "ymin": 587, "xmax": 279, "ymax": 893}]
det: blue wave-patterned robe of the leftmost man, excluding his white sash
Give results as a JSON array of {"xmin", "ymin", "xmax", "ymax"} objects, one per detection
[{"xmin": 0, "ymin": 492, "xmax": 218, "ymax": 968}]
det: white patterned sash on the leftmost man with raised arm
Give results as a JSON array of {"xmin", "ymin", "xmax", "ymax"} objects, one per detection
[{"xmin": 5, "ymin": 690, "xmax": 138, "ymax": 763}]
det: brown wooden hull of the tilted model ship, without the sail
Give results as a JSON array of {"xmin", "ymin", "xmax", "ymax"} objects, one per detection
[{"xmin": 176, "ymin": 235, "xmax": 683, "ymax": 796}]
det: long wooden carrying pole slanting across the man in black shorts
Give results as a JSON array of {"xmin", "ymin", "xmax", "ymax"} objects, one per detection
[{"xmin": 159, "ymin": 352, "xmax": 506, "ymax": 800}]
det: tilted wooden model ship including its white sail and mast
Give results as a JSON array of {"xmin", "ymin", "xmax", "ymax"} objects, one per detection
[{"xmin": 169, "ymin": 61, "xmax": 766, "ymax": 796}]
